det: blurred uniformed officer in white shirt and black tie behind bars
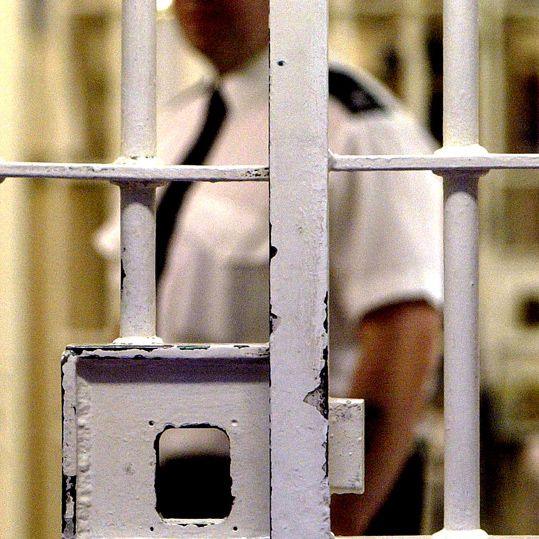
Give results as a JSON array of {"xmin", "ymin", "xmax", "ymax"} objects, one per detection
[{"xmin": 99, "ymin": 0, "xmax": 442, "ymax": 535}]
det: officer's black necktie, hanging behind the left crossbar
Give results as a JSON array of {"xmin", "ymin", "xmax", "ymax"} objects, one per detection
[{"xmin": 155, "ymin": 90, "xmax": 230, "ymax": 282}]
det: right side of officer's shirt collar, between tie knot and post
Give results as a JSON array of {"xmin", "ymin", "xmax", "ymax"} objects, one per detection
[{"xmin": 218, "ymin": 49, "xmax": 269, "ymax": 110}]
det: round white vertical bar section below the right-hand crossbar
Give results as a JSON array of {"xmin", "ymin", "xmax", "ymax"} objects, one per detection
[{"xmin": 444, "ymin": 175, "xmax": 480, "ymax": 530}]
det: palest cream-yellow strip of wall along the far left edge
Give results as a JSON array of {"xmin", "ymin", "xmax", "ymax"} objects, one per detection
[{"xmin": 0, "ymin": 2, "xmax": 31, "ymax": 539}]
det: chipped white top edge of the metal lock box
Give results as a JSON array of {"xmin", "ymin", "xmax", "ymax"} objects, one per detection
[{"xmin": 67, "ymin": 343, "xmax": 269, "ymax": 361}]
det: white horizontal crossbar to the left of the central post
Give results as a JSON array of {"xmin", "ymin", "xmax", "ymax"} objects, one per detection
[{"xmin": 0, "ymin": 162, "xmax": 269, "ymax": 183}]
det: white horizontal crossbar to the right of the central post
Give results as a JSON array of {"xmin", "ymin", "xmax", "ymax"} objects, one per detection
[{"xmin": 331, "ymin": 153, "xmax": 539, "ymax": 171}]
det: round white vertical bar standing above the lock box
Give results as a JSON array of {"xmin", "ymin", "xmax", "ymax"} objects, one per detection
[{"xmin": 119, "ymin": 0, "xmax": 156, "ymax": 342}]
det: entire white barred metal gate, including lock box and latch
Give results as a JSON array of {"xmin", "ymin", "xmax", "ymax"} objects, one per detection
[{"xmin": 0, "ymin": 0, "xmax": 539, "ymax": 539}]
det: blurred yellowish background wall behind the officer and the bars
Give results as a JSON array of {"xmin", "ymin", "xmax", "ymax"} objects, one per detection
[{"xmin": 0, "ymin": 0, "xmax": 539, "ymax": 539}]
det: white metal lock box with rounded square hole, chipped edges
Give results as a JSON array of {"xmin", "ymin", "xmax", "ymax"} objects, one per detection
[{"xmin": 63, "ymin": 345, "xmax": 269, "ymax": 539}]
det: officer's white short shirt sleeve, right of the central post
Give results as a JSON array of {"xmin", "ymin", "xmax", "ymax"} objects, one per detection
[{"xmin": 330, "ymin": 107, "xmax": 442, "ymax": 320}]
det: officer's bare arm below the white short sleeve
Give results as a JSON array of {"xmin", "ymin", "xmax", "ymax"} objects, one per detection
[{"xmin": 332, "ymin": 302, "xmax": 440, "ymax": 535}]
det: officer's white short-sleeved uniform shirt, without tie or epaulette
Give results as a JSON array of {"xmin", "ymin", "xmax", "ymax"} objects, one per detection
[{"xmin": 99, "ymin": 52, "xmax": 442, "ymax": 395}]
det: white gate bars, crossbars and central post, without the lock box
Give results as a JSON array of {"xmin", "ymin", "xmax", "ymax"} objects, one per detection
[{"xmin": 0, "ymin": 0, "xmax": 539, "ymax": 539}]
